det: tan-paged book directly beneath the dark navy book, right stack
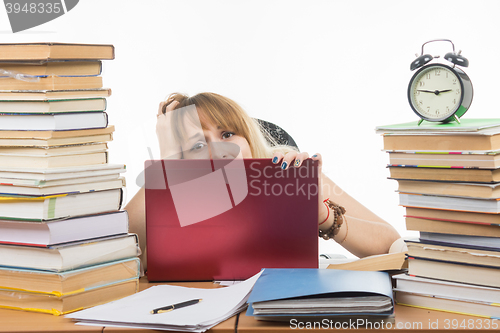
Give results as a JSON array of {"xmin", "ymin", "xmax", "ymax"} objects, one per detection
[{"xmin": 406, "ymin": 240, "xmax": 500, "ymax": 268}]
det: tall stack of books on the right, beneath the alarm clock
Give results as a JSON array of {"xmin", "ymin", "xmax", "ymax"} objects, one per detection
[{"xmin": 377, "ymin": 119, "xmax": 500, "ymax": 318}]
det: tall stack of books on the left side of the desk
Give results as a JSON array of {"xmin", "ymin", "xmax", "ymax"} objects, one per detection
[{"xmin": 0, "ymin": 43, "xmax": 140, "ymax": 315}]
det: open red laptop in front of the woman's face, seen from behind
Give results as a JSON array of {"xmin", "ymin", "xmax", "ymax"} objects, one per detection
[{"xmin": 145, "ymin": 159, "xmax": 319, "ymax": 281}]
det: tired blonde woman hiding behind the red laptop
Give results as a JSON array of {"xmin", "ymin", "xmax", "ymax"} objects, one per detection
[{"xmin": 125, "ymin": 93, "xmax": 400, "ymax": 265}]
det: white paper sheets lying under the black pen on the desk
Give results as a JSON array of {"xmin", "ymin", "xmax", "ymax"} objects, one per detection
[{"xmin": 66, "ymin": 273, "xmax": 260, "ymax": 332}]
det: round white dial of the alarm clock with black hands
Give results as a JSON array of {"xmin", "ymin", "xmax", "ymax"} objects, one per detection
[{"xmin": 408, "ymin": 64, "xmax": 463, "ymax": 121}]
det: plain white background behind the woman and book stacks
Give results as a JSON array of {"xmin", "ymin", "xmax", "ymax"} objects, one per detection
[{"xmin": 0, "ymin": 0, "xmax": 500, "ymax": 252}]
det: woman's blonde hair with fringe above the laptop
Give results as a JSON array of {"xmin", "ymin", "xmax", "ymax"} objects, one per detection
[{"xmin": 162, "ymin": 92, "xmax": 297, "ymax": 158}]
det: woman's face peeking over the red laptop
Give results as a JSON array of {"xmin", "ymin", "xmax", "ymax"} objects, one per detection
[{"xmin": 182, "ymin": 116, "xmax": 252, "ymax": 159}]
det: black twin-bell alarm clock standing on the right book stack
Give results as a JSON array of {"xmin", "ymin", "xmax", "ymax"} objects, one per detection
[{"xmin": 408, "ymin": 39, "xmax": 473, "ymax": 125}]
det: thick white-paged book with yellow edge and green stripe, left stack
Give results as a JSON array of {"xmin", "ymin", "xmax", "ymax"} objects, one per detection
[{"xmin": 0, "ymin": 189, "xmax": 123, "ymax": 221}]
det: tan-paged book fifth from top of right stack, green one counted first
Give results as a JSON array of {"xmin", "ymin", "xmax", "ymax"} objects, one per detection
[{"xmin": 398, "ymin": 179, "xmax": 500, "ymax": 199}]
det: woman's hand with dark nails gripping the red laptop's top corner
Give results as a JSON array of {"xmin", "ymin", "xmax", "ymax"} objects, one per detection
[{"xmin": 272, "ymin": 151, "xmax": 328, "ymax": 223}]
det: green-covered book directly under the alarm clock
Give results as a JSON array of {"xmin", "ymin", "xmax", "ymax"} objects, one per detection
[{"xmin": 375, "ymin": 118, "xmax": 500, "ymax": 135}]
